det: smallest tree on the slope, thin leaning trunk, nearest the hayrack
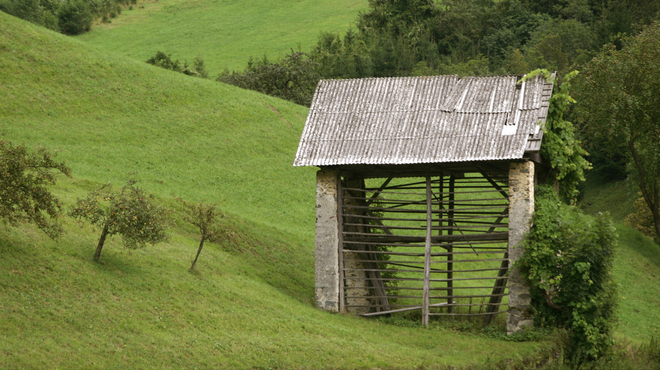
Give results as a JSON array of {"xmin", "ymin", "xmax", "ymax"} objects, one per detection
[{"xmin": 179, "ymin": 198, "xmax": 226, "ymax": 271}]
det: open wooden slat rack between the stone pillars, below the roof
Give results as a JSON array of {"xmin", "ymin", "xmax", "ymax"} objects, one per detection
[{"xmin": 339, "ymin": 173, "xmax": 508, "ymax": 324}]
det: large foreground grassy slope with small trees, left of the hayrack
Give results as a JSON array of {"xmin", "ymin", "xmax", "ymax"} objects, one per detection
[{"xmin": 0, "ymin": 13, "xmax": 564, "ymax": 369}]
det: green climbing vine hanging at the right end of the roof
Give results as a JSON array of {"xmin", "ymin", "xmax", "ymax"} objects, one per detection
[{"xmin": 523, "ymin": 69, "xmax": 591, "ymax": 203}]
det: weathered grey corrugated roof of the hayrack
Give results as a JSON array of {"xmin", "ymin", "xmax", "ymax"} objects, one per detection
[{"xmin": 294, "ymin": 76, "xmax": 552, "ymax": 166}]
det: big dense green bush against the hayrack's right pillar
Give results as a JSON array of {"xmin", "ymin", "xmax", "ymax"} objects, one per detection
[{"xmin": 518, "ymin": 186, "xmax": 617, "ymax": 361}]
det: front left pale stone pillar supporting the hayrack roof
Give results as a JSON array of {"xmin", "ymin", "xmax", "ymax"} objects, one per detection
[{"xmin": 314, "ymin": 169, "xmax": 339, "ymax": 312}]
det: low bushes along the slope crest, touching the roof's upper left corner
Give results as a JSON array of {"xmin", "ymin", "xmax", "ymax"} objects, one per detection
[{"xmin": 218, "ymin": 50, "xmax": 321, "ymax": 106}]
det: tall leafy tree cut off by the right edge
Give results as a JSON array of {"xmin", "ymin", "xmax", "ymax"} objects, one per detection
[{"xmin": 578, "ymin": 22, "xmax": 660, "ymax": 240}]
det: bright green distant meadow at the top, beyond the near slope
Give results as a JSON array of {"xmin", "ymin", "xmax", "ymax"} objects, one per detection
[{"xmin": 79, "ymin": 0, "xmax": 368, "ymax": 76}]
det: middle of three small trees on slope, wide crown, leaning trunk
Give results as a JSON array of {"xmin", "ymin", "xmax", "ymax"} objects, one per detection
[{"xmin": 69, "ymin": 180, "xmax": 167, "ymax": 261}]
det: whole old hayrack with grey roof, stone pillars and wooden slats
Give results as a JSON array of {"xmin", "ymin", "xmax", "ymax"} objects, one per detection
[{"xmin": 294, "ymin": 76, "xmax": 553, "ymax": 332}]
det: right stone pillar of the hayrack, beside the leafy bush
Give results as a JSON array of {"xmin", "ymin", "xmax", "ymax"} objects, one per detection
[{"xmin": 506, "ymin": 161, "xmax": 534, "ymax": 334}]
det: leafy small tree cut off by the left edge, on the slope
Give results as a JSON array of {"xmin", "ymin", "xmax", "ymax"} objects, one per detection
[{"xmin": 0, "ymin": 140, "xmax": 71, "ymax": 239}]
